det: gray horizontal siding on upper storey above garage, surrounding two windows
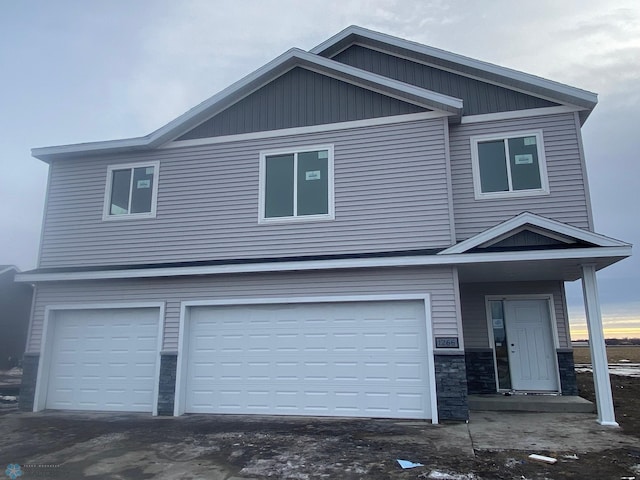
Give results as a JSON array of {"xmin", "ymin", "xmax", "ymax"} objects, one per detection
[{"xmin": 40, "ymin": 118, "xmax": 452, "ymax": 268}]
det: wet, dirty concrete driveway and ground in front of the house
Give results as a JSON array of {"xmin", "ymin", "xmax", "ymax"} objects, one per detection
[{"xmin": 0, "ymin": 411, "xmax": 640, "ymax": 480}]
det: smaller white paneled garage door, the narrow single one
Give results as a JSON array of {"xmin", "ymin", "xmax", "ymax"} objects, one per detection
[{"xmin": 46, "ymin": 308, "xmax": 159, "ymax": 412}]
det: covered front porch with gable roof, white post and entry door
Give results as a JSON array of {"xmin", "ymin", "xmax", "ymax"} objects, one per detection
[{"xmin": 441, "ymin": 213, "xmax": 631, "ymax": 426}]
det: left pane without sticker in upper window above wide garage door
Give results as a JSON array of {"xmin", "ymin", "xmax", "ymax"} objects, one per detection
[{"xmin": 264, "ymin": 154, "xmax": 293, "ymax": 218}]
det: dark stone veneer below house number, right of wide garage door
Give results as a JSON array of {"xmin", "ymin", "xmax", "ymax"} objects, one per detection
[{"xmin": 433, "ymin": 355, "xmax": 469, "ymax": 420}]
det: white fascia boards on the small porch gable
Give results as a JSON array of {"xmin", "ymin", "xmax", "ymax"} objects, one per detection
[{"xmin": 438, "ymin": 212, "xmax": 630, "ymax": 255}]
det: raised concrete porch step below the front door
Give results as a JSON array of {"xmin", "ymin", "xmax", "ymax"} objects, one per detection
[{"xmin": 468, "ymin": 394, "xmax": 595, "ymax": 413}]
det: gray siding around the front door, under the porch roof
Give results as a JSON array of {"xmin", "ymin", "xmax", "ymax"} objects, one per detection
[{"xmin": 460, "ymin": 281, "xmax": 571, "ymax": 348}]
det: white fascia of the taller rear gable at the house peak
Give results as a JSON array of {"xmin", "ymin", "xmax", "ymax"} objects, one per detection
[{"xmin": 310, "ymin": 25, "xmax": 598, "ymax": 109}]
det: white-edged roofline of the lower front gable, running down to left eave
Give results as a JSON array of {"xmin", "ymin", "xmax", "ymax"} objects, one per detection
[{"xmin": 31, "ymin": 48, "xmax": 462, "ymax": 161}]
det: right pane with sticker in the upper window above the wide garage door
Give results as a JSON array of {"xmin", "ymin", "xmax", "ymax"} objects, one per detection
[{"xmin": 298, "ymin": 150, "xmax": 329, "ymax": 215}]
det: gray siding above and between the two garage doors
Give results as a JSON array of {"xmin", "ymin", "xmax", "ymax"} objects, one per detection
[{"xmin": 27, "ymin": 267, "xmax": 462, "ymax": 352}]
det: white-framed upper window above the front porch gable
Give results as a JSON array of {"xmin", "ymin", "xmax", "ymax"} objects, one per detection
[{"xmin": 471, "ymin": 130, "xmax": 549, "ymax": 199}]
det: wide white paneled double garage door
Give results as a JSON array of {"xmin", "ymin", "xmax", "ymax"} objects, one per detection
[{"xmin": 185, "ymin": 301, "xmax": 432, "ymax": 418}]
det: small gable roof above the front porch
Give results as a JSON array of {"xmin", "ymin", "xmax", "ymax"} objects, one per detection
[{"xmin": 438, "ymin": 212, "xmax": 630, "ymax": 255}]
